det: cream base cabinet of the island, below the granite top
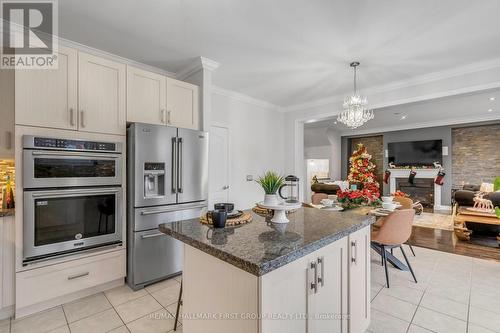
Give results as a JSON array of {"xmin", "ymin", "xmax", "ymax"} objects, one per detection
[{"xmin": 183, "ymin": 226, "xmax": 370, "ymax": 333}]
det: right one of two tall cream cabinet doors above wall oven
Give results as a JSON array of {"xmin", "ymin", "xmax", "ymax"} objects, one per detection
[{"xmin": 78, "ymin": 52, "xmax": 126, "ymax": 135}]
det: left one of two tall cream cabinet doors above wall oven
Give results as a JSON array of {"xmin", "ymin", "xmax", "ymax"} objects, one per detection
[{"xmin": 15, "ymin": 46, "xmax": 77, "ymax": 129}]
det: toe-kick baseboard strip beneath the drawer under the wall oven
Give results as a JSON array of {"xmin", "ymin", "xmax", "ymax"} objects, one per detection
[{"xmin": 15, "ymin": 278, "xmax": 125, "ymax": 319}]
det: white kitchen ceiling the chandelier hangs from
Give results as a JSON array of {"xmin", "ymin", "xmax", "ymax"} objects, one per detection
[{"xmin": 59, "ymin": 0, "xmax": 500, "ymax": 106}]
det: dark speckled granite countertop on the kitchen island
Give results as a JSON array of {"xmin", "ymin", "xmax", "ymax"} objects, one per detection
[{"xmin": 160, "ymin": 208, "xmax": 375, "ymax": 276}]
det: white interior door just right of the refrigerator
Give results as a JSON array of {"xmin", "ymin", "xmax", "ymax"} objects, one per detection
[{"xmin": 208, "ymin": 126, "xmax": 230, "ymax": 209}]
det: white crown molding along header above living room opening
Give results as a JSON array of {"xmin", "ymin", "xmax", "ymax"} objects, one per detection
[{"xmin": 282, "ymin": 58, "xmax": 500, "ymax": 112}]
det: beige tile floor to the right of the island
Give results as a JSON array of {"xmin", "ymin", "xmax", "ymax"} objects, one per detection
[{"xmin": 368, "ymin": 245, "xmax": 500, "ymax": 333}]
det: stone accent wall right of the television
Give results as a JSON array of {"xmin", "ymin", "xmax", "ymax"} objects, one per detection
[{"xmin": 451, "ymin": 124, "xmax": 500, "ymax": 188}]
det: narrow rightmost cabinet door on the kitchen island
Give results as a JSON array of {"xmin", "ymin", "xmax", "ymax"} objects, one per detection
[{"xmin": 349, "ymin": 227, "xmax": 370, "ymax": 333}]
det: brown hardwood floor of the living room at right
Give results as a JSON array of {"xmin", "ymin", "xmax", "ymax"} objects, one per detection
[{"xmin": 408, "ymin": 226, "xmax": 500, "ymax": 262}]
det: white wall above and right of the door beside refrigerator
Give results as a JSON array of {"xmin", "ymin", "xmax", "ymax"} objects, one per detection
[{"xmin": 211, "ymin": 89, "xmax": 285, "ymax": 209}]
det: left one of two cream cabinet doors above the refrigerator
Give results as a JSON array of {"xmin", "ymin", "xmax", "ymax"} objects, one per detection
[{"xmin": 127, "ymin": 66, "xmax": 167, "ymax": 125}]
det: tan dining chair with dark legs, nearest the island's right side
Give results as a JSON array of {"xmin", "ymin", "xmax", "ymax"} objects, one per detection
[{"xmin": 371, "ymin": 209, "xmax": 417, "ymax": 288}]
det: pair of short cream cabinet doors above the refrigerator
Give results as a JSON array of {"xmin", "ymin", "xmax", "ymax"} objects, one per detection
[{"xmin": 127, "ymin": 66, "xmax": 199, "ymax": 130}]
